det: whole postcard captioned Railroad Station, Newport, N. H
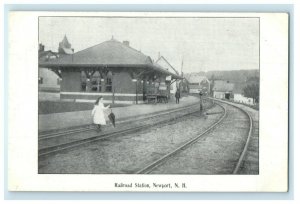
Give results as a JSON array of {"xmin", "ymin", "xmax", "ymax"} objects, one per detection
[{"xmin": 8, "ymin": 11, "xmax": 289, "ymax": 192}]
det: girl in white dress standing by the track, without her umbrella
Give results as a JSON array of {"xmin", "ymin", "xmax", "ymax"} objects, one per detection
[{"xmin": 92, "ymin": 97, "xmax": 110, "ymax": 131}]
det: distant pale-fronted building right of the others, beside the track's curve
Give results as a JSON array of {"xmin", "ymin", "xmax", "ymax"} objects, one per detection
[{"xmin": 212, "ymin": 80, "xmax": 234, "ymax": 100}]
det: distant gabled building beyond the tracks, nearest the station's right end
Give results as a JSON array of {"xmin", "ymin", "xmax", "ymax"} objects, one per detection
[{"xmin": 187, "ymin": 74, "xmax": 210, "ymax": 94}]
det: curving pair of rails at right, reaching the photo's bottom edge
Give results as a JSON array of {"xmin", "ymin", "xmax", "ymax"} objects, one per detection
[{"xmin": 135, "ymin": 101, "xmax": 253, "ymax": 174}]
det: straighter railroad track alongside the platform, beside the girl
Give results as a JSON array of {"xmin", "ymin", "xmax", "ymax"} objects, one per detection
[{"xmin": 38, "ymin": 100, "xmax": 213, "ymax": 157}]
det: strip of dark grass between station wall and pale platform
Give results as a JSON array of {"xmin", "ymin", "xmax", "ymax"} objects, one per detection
[{"xmin": 39, "ymin": 101, "xmax": 128, "ymax": 114}]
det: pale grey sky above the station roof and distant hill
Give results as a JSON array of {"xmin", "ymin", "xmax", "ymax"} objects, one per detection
[{"xmin": 39, "ymin": 17, "xmax": 259, "ymax": 73}]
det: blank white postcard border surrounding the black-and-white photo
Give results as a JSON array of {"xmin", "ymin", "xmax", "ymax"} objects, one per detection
[{"xmin": 8, "ymin": 12, "xmax": 288, "ymax": 192}]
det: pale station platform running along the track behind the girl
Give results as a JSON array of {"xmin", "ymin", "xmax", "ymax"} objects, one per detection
[{"xmin": 38, "ymin": 96, "xmax": 199, "ymax": 132}]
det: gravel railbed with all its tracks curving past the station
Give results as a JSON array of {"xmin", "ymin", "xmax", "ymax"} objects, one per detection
[{"xmin": 39, "ymin": 100, "xmax": 258, "ymax": 175}]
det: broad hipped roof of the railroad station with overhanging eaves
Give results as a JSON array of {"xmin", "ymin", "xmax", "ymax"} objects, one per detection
[{"xmin": 39, "ymin": 39, "xmax": 181, "ymax": 79}]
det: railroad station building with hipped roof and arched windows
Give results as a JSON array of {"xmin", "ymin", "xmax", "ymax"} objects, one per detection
[{"xmin": 39, "ymin": 35, "xmax": 182, "ymax": 104}]
